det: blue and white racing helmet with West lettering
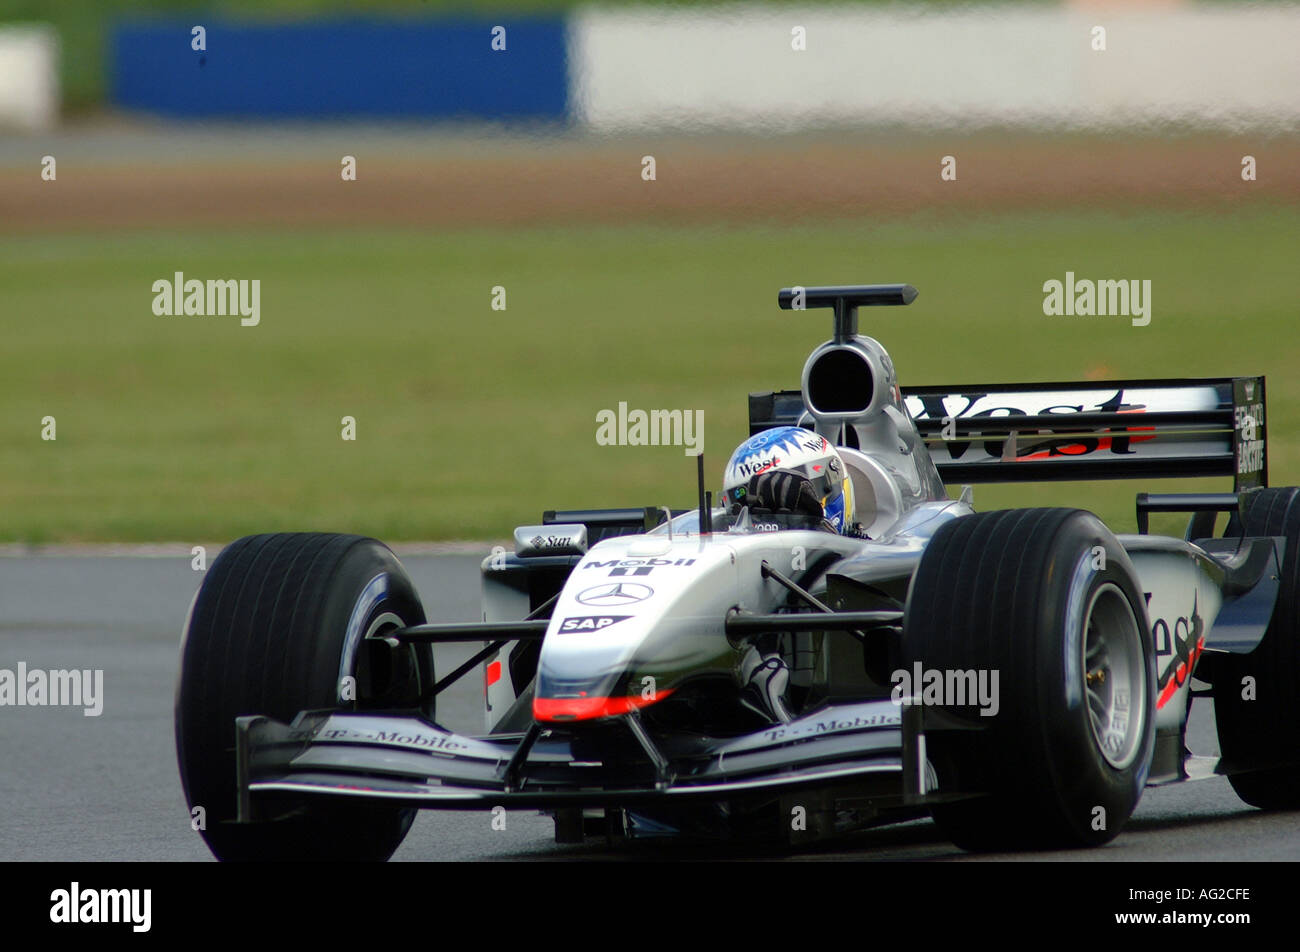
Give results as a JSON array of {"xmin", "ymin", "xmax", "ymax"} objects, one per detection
[{"xmin": 723, "ymin": 427, "xmax": 855, "ymax": 535}]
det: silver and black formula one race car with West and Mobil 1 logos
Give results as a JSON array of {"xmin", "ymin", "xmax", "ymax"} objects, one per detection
[{"xmin": 176, "ymin": 285, "xmax": 1300, "ymax": 860}]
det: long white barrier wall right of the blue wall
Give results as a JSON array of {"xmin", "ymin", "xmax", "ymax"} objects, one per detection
[{"xmin": 569, "ymin": 5, "xmax": 1300, "ymax": 131}]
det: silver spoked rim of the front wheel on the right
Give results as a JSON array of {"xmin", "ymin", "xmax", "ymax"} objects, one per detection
[{"xmin": 1082, "ymin": 583, "xmax": 1148, "ymax": 770}]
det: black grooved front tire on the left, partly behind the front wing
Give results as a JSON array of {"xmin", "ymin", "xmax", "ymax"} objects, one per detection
[{"xmin": 176, "ymin": 532, "xmax": 433, "ymax": 861}]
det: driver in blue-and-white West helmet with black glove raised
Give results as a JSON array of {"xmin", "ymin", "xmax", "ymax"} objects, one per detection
[{"xmin": 723, "ymin": 427, "xmax": 857, "ymax": 536}]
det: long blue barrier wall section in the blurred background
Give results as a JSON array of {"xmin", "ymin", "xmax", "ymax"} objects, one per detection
[{"xmin": 109, "ymin": 16, "xmax": 568, "ymax": 120}]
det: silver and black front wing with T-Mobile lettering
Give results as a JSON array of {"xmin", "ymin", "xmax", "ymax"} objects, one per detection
[{"xmin": 237, "ymin": 700, "xmax": 932, "ymax": 822}]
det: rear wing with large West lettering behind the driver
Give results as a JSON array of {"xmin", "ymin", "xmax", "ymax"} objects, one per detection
[{"xmin": 749, "ymin": 377, "xmax": 1269, "ymax": 492}]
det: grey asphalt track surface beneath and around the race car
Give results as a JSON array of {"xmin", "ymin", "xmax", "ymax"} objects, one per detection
[{"xmin": 0, "ymin": 554, "xmax": 1300, "ymax": 862}]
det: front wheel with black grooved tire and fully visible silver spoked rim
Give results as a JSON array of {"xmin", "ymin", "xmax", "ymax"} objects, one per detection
[{"xmin": 904, "ymin": 509, "xmax": 1156, "ymax": 851}]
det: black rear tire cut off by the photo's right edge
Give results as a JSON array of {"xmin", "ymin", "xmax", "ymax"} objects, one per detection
[{"xmin": 1214, "ymin": 486, "xmax": 1300, "ymax": 810}]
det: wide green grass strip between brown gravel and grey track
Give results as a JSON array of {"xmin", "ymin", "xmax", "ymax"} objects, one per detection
[{"xmin": 0, "ymin": 202, "xmax": 1300, "ymax": 542}]
